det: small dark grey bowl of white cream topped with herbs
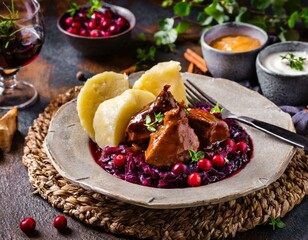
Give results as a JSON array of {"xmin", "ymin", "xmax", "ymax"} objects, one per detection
[{"xmin": 256, "ymin": 41, "xmax": 308, "ymax": 106}]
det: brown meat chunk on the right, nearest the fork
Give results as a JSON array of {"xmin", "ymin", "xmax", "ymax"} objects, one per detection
[{"xmin": 187, "ymin": 109, "xmax": 229, "ymax": 147}]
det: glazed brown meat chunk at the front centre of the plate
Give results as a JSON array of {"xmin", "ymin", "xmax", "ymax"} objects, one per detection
[{"xmin": 145, "ymin": 106, "xmax": 199, "ymax": 167}]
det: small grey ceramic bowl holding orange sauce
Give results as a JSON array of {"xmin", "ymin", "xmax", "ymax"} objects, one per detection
[{"xmin": 201, "ymin": 22, "xmax": 268, "ymax": 83}]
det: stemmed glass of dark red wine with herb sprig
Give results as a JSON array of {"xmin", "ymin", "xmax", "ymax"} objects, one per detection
[{"xmin": 0, "ymin": 0, "xmax": 45, "ymax": 110}]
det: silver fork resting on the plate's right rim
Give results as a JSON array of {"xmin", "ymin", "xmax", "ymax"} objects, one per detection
[{"xmin": 184, "ymin": 79, "xmax": 308, "ymax": 151}]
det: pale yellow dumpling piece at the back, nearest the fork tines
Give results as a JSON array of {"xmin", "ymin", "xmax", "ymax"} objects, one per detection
[{"xmin": 133, "ymin": 61, "xmax": 186, "ymax": 102}]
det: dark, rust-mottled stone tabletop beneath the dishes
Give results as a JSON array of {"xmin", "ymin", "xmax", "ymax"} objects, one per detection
[{"xmin": 0, "ymin": 0, "xmax": 308, "ymax": 240}]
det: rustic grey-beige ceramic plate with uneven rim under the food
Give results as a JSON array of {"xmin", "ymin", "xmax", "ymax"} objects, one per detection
[{"xmin": 44, "ymin": 73, "xmax": 295, "ymax": 209}]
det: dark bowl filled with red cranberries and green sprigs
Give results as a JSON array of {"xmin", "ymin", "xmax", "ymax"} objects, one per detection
[{"xmin": 57, "ymin": 1, "xmax": 136, "ymax": 56}]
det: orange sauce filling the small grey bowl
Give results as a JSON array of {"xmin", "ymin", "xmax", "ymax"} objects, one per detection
[{"xmin": 210, "ymin": 35, "xmax": 261, "ymax": 52}]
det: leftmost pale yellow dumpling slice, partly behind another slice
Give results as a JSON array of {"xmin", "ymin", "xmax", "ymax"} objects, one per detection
[{"xmin": 77, "ymin": 72, "xmax": 129, "ymax": 140}]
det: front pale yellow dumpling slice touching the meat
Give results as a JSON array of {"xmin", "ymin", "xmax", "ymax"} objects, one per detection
[{"xmin": 93, "ymin": 89, "xmax": 155, "ymax": 148}]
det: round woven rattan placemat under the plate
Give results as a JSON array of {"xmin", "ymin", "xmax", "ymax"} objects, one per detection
[{"xmin": 23, "ymin": 87, "xmax": 308, "ymax": 240}]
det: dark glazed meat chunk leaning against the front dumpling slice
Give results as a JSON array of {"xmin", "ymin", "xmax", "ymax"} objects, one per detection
[{"xmin": 125, "ymin": 85, "xmax": 176, "ymax": 147}]
